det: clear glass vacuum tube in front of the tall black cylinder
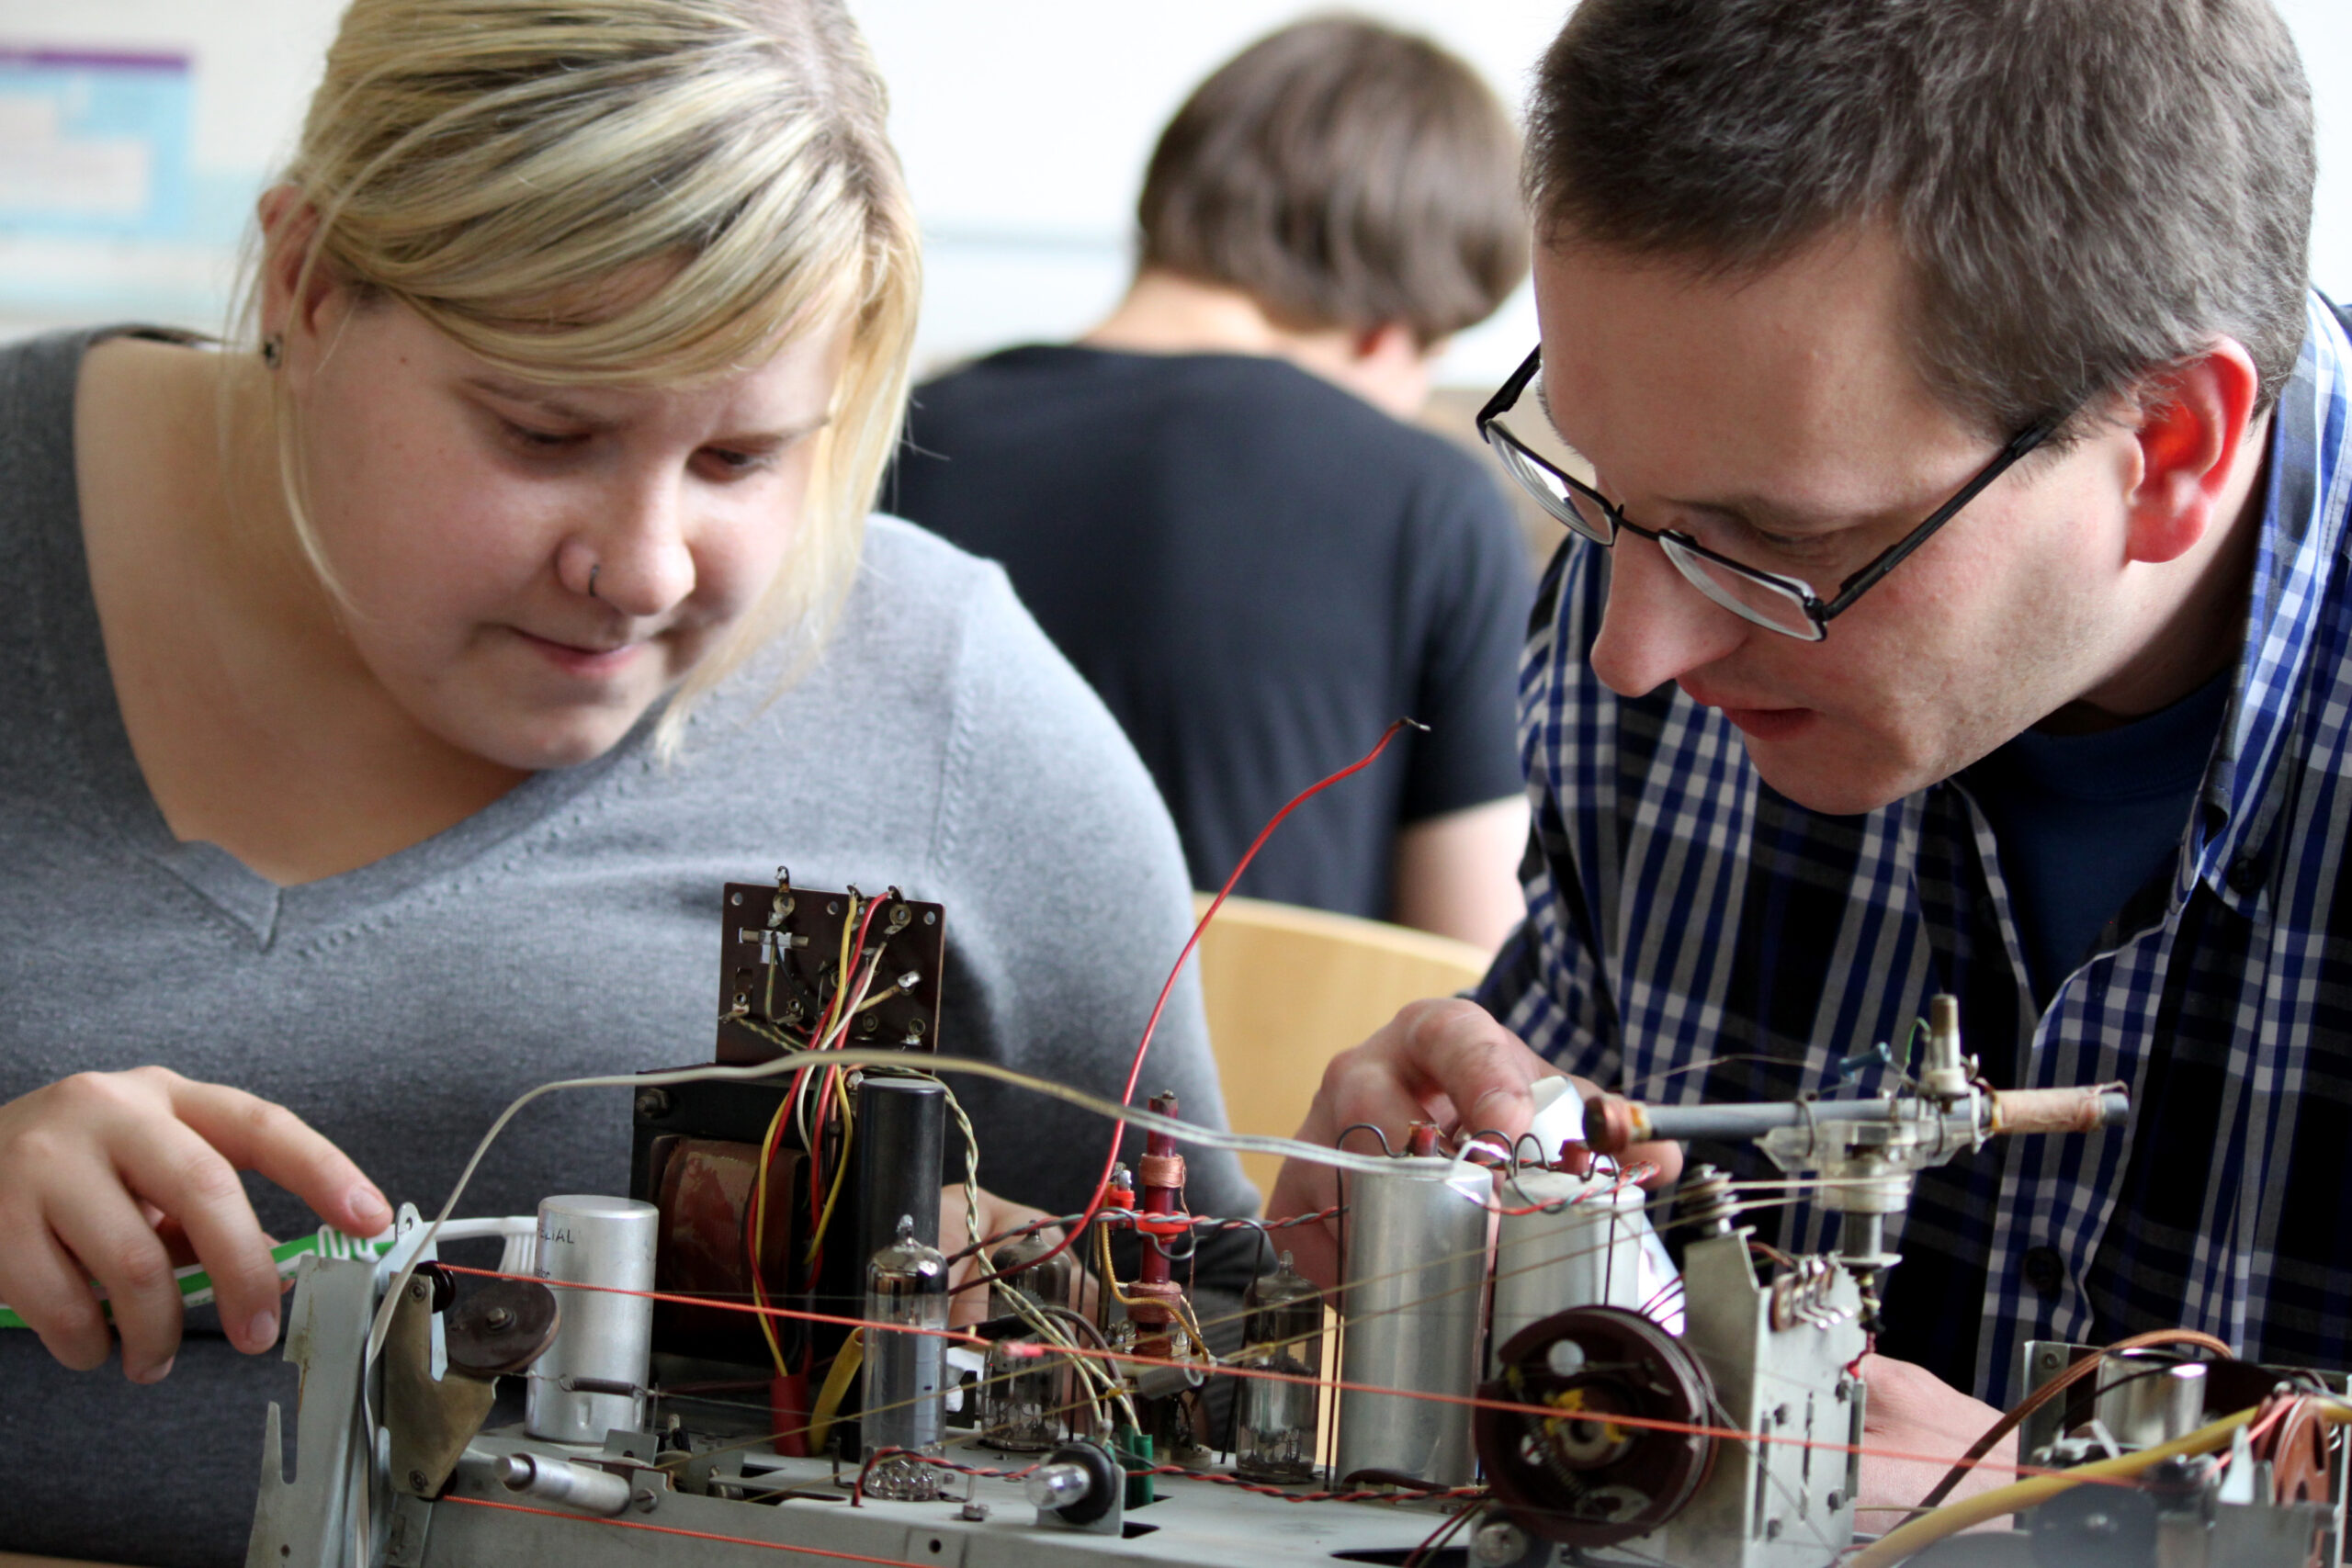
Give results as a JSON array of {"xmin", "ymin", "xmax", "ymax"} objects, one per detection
[{"xmin": 861, "ymin": 1215, "xmax": 948, "ymax": 1500}]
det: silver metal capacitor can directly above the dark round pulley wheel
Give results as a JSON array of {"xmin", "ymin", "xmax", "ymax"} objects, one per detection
[{"xmin": 1487, "ymin": 1170, "xmax": 1675, "ymax": 1373}]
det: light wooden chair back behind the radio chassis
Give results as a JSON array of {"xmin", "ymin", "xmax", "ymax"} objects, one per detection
[{"xmin": 1194, "ymin": 894, "xmax": 1488, "ymax": 1197}]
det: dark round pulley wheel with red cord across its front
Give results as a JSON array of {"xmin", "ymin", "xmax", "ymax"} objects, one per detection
[{"xmin": 1473, "ymin": 1307, "xmax": 1714, "ymax": 1547}]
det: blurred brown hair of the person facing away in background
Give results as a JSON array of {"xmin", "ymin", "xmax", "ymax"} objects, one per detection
[{"xmin": 1136, "ymin": 17, "xmax": 1526, "ymax": 345}]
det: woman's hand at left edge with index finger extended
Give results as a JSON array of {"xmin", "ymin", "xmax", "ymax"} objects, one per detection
[{"xmin": 0, "ymin": 1067, "xmax": 393, "ymax": 1382}]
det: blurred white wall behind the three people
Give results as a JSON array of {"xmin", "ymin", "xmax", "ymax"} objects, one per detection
[{"xmin": 0, "ymin": 0, "xmax": 2352, "ymax": 386}]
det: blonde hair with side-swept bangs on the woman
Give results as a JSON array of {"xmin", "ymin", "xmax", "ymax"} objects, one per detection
[{"xmin": 247, "ymin": 0, "xmax": 922, "ymax": 752}]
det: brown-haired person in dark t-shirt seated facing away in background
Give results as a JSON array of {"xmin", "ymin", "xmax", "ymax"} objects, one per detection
[{"xmin": 882, "ymin": 17, "xmax": 1533, "ymax": 947}]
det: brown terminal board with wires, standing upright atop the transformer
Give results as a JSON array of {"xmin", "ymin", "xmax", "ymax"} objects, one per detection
[{"xmin": 718, "ymin": 877, "xmax": 948, "ymax": 1063}]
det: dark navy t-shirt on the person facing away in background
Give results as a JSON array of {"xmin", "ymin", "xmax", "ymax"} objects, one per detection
[{"xmin": 882, "ymin": 345, "xmax": 1533, "ymax": 919}]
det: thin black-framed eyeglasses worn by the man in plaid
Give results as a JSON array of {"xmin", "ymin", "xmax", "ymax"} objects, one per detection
[{"xmin": 1477, "ymin": 348, "xmax": 2067, "ymax": 642}]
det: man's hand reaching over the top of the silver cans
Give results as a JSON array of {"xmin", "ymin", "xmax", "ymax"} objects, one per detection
[{"xmin": 1268, "ymin": 997, "xmax": 1681, "ymax": 1288}]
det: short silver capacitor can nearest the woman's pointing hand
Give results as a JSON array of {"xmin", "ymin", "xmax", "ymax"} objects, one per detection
[{"xmin": 525, "ymin": 1194, "xmax": 661, "ymax": 1446}]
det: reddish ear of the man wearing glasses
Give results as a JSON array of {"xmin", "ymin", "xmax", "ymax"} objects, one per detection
[{"xmin": 2126, "ymin": 339, "xmax": 2260, "ymax": 564}]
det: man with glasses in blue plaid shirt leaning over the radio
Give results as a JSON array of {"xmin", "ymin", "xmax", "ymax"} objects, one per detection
[{"xmin": 1272, "ymin": 0, "xmax": 2352, "ymax": 1523}]
